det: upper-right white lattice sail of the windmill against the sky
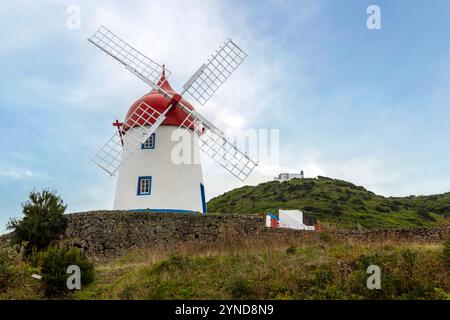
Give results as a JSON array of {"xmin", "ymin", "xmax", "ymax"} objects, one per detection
[{"xmin": 183, "ymin": 39, "xmax": 247, "ymax": 105}]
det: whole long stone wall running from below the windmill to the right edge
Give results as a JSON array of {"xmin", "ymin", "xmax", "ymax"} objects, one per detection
[{"xmin": 65, "ymin": 211, "xmax": 450, "ymax": 258}]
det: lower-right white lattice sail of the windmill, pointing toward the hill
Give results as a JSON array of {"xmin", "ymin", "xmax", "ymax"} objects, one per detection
[{"xmin": 179, "ymin": 110, "xmax": 258, "ymax": 182}]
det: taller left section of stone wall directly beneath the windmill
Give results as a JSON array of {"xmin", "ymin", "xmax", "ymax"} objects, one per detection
[{"xmin": 65, "ymin": 211, "xmax": 265, "ymax": 257}]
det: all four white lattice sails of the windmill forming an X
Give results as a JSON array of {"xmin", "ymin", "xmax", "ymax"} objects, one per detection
[{"xmin": 88, "ymin": 26, "xmax": 257, "ymax": 181}]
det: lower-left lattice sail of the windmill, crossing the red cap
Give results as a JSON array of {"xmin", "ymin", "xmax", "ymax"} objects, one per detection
[{"xmin": 92, "ymin": 101, "xmax": 166, "ymax": 176}]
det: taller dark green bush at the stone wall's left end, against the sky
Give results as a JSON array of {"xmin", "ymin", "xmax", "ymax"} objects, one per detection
[{"xmin": 7, "ymin": 190, "xmax": 67, "ymax": 254}]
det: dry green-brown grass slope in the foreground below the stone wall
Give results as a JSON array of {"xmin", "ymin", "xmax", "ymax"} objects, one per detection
[{"xmin": 0, "ymin": 235, "xmax": 450, "ymax": 300}]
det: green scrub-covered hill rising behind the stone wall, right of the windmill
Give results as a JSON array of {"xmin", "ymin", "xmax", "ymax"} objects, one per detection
[{"xmin": 208, "ymin": 177, "xmax": 450, "ymax": 228}]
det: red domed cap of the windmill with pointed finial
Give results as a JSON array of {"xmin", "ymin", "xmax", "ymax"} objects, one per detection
[{"xmin": 124, "ymin": 65, "xmax": 194, "ymax": 130}]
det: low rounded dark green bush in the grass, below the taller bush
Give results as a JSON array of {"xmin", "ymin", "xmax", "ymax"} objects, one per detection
[{"xmin": 41, "ymin": 246, "xmax": 94, "ymax": 296}]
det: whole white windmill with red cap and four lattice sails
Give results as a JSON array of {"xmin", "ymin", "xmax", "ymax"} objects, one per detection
[{"xmin": 88, "ymin": 26, "xmax": 257, "ymax": 213}]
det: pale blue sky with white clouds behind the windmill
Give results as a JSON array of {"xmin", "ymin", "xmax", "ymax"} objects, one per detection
[{"xmin": 0, "ymin": 0, "xmax": 450, "ymax": 232}]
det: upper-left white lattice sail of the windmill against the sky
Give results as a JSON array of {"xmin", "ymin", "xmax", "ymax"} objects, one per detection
[{"xmin": 88, "ymin": 25, "xmax": 171, "ymax": 88}]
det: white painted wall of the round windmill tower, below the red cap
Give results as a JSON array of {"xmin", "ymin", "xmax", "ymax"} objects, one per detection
[{"xmin": 114, "ymin": 125, "xmax": 203, "ymax": 212}]
